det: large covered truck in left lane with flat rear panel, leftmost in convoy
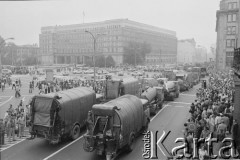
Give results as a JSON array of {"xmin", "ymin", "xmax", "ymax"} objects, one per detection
[{"xmin": 30, "ymin": 87, "xmax": 96, "ymax": 144}]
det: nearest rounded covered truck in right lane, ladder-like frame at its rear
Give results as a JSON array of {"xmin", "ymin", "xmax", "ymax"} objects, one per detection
[{"xmin": 83, "ymin": 95, "xmax": 150, "ymax": 160}]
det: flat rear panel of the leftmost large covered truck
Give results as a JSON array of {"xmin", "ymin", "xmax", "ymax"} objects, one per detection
[{"xmin": 33, "ymin": 97, "xmax": 53, "ymax": 127}]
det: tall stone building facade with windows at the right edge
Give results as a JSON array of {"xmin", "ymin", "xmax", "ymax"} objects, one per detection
[{"xmin": 216, "ymin": 0, "xmax": 240, "ymax": 70}]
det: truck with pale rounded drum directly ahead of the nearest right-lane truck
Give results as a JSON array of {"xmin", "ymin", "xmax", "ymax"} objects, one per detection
[{"xmin": 141, "ymin": 87, "xmax": 164, "ymax": 115}]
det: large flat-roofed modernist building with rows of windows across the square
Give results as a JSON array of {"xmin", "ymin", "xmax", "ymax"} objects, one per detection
[{"xmin": 39, "ymin": 19, "xmax": 177, "ymax": 65}]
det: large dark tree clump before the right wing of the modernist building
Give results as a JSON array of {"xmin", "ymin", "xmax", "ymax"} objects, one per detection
[{"xmin": 123, "ymin": 42, "xmax": 152, "ymax": 65}]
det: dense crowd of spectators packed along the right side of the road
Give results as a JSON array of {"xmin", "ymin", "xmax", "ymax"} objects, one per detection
[{"xmin": 184, "ymin": 73, "xmax": 236, "ymax": 160}]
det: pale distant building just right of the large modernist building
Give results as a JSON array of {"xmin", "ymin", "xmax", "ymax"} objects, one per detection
[{"xmin": 177, "ymin": 39, "xmax": 196, "ymax": 64}]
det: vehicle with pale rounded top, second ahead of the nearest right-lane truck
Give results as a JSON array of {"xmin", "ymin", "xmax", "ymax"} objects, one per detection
[{"xmin": 164, "ymin": 81, "xmax": 180, "ymax": 101}]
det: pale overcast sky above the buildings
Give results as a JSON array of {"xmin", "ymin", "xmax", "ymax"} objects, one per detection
[{"xmin": 0, "ymin": 0, "xmax": 220, "ymax": 48}]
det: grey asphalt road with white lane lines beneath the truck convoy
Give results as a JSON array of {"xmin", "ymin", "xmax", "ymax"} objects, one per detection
[{"xmin": 0, "ymin": 79, "xmax": 199, "ymax": 160}]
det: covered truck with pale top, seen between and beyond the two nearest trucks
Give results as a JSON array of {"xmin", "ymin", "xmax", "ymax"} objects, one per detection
[{"xmin": 105, "ymin": 78, "xmax": 140, "ymax": 100}]
